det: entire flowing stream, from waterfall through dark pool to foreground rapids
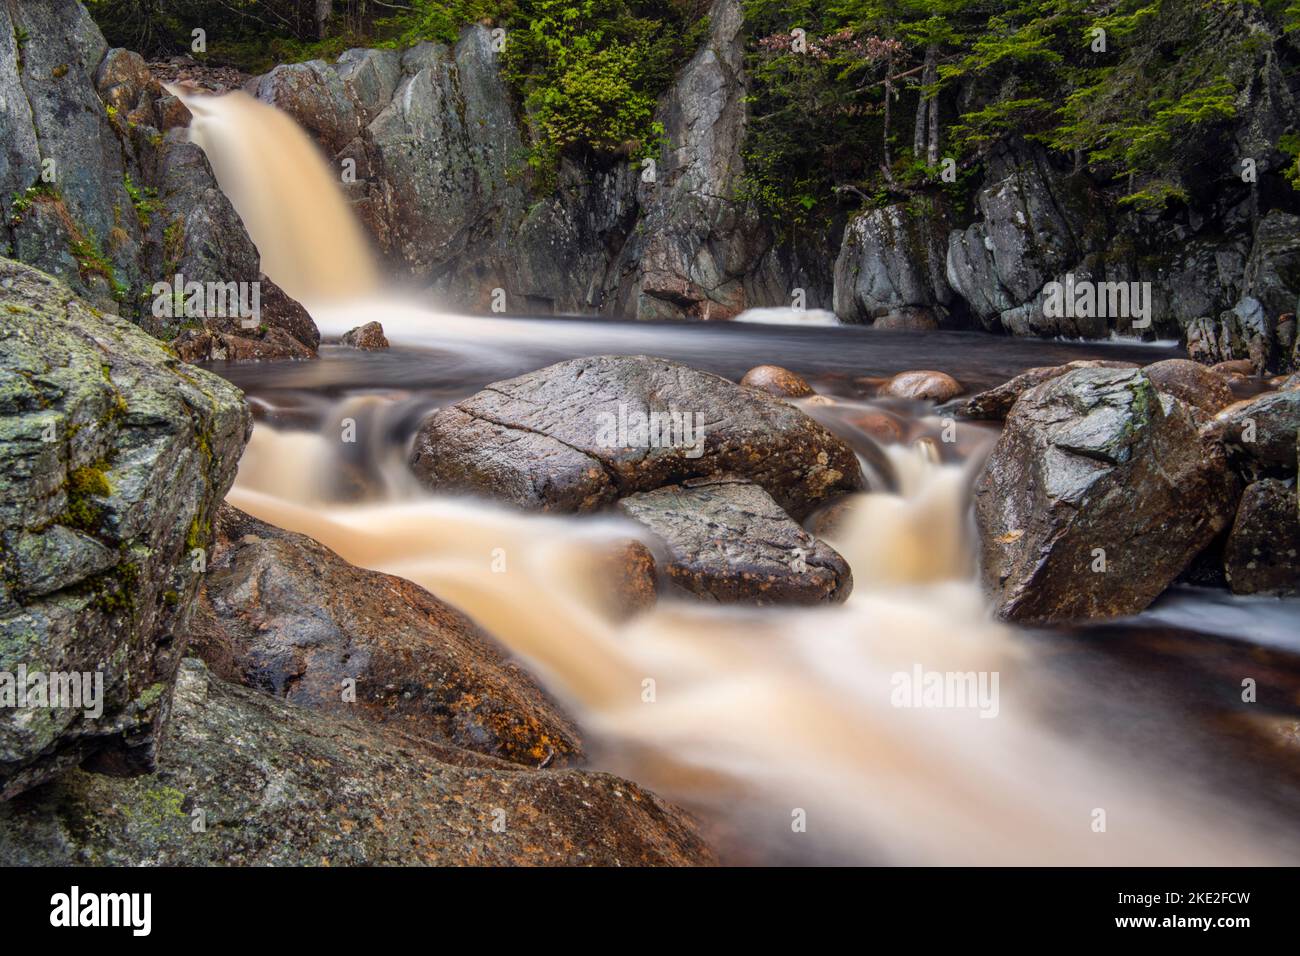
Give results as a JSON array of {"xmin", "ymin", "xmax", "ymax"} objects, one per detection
[{"xmin": 183, "ymin": 89, "xmax": 1300, "ymax": 864}]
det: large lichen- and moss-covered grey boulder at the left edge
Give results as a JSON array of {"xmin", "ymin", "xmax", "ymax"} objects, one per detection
[{"xmin": 0, "ymin": 260, "xmax": 251, "ymax": 797}]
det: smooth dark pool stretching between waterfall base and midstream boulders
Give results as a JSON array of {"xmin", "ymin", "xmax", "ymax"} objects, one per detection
[{"xmin": 213, "ymin": 317, "xmax": 1183, "ymax": 398}]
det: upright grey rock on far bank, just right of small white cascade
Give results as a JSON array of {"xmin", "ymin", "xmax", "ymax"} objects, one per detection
[{"xmin": 833, "ymin": 200, "xmax": 954, "ymax": 328}]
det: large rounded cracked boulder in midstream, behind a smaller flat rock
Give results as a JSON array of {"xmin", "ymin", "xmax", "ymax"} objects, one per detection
[{"xmin": 410, "ymin": 355, "xmax": 862, "ymax": 518}]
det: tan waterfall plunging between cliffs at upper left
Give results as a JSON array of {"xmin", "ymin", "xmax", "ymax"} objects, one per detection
[{"xmin": 166, "ymin": 86, "xmax": 378, "ymax": 306}]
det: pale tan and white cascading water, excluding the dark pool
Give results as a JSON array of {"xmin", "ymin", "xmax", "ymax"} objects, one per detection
[{"xmin": 185, "ymin": 94, "xmax": 1297, "ymax": 864}]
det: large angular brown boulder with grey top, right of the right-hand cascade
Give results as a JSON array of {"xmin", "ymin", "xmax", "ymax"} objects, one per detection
[{"xmin": 975, "ymin": 368, "xmax": 1238, "ymax": 623}]
